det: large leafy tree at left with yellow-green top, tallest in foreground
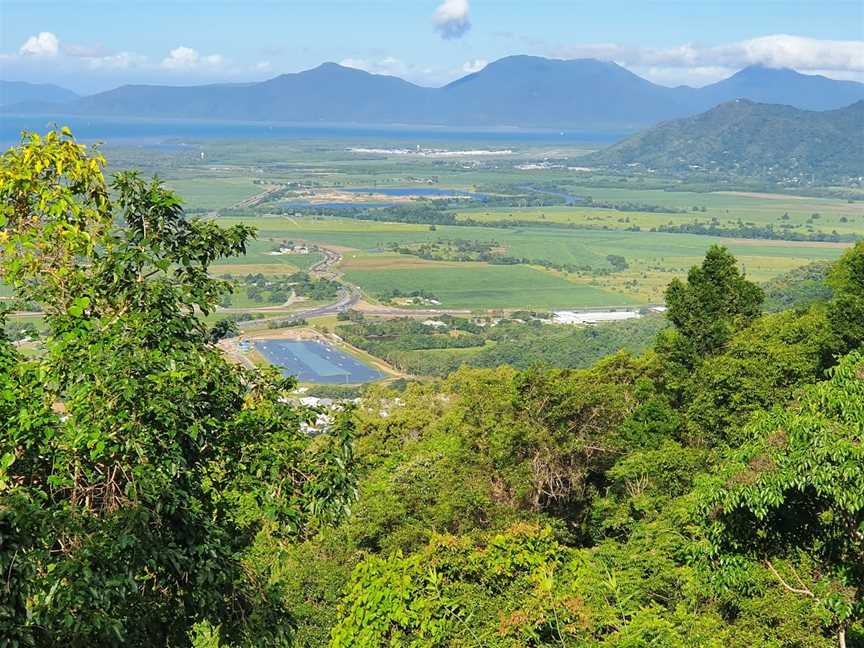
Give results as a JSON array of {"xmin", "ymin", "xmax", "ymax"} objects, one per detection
[{"xmin": 0, "ymin": 129, "xmax": 353, "ymax": 646}]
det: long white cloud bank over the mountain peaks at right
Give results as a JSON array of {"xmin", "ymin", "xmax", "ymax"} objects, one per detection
[{"xmin": 553, "ymin": 34, "xmax": 864, "ymax": 83}]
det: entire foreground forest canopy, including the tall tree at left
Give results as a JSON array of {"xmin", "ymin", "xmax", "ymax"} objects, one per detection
[{"xmin": 0, "ymin": 132, "xmax": 864, "ymax": 648}]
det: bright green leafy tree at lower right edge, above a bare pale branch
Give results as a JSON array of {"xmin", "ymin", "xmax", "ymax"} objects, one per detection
[{"xmin": 702, "ymin": 353, "xmax": 864, "ymax": 646}]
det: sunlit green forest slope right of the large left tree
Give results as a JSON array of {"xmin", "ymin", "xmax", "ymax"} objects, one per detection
[{"xmin": 320, "ymin": 242, "xmax": 864, "ymax": 648}]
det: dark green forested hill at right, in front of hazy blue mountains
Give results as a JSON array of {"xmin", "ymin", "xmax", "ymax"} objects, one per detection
[{"xmin": 583, "ymin": 99, "xmax": 864, "ymax": 179}]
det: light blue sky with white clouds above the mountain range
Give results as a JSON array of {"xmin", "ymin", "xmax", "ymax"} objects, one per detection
[{"xmin": 0, "ymin": 0, "xmax": 864, "ymax": 93}]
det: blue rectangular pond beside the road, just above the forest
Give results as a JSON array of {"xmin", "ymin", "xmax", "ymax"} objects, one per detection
[{"xmin": 255, "ymin": 340, "xmax": 384, "ymax": 385}]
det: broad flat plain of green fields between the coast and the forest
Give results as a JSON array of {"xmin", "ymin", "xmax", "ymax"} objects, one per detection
[{"xmin": 86, "ymin": 141, "xmax": 864, "ymax": 308}]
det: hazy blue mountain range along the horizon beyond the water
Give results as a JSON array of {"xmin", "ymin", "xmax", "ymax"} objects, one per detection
[{"xmin": 3, "ymin": 56, "xmax": 864, "ymax": 131}]
